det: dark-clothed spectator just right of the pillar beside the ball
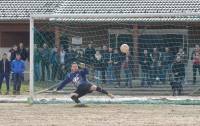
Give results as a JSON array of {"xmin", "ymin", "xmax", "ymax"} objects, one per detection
[{"xmin": 140, "ymin": 49, "xmax": 151, "ymax": 87}]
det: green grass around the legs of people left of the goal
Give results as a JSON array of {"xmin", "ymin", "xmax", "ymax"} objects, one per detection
[{"xmin": 1, "ymin": 81, "xmax": 29, "ymax": 95}]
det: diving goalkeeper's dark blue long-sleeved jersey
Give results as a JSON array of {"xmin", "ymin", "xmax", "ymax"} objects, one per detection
[{"xmin": 57, "ymin": 68, "xmax": 89, "ymax": 90}]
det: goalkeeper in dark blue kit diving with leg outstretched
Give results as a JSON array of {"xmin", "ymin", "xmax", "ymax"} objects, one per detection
[{"xmin": 56, "ymin": 63, "xmax": 114, "ymax": 103}]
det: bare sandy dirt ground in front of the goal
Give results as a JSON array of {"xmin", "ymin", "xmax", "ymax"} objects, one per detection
[{"xmin": 0, "ymin": 104, "xmax": 200, "ymax": 126}]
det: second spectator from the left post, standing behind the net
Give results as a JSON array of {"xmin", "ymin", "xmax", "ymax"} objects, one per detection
[{"xmin": 41, "ymin": 43, "xmax": 50, "ymax": 81}]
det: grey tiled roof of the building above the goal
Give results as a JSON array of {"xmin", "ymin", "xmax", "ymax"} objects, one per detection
[{"xmin": 0, "ymin": 0, "xmax": 200, "ymax": 21}]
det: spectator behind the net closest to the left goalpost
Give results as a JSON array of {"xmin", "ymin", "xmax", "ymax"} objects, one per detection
[{"xmin": 34, "ymin": 44, "xmax": 41, "ymax": 81}]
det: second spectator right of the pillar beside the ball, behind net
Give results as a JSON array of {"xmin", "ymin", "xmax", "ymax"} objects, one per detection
[{"xmin": 150, "ymin": 48, "xmax": 162, "ymax": 83}]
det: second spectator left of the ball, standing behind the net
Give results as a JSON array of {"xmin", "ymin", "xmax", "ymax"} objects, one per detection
[{"xmin": 105, "ymin": 48, "xmax": 113, "ymax": 84}]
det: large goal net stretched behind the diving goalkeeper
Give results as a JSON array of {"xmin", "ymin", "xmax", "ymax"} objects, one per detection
[{"xmin": 30, "ymin": 14, "xmax": 200, "ymax": 100}]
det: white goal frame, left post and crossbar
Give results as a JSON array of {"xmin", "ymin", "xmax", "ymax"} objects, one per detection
[{"xmin": 29, "ymin": 12, "xmax": 200, "ymax": 98}]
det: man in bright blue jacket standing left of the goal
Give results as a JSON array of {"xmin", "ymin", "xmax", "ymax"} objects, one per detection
[{"xmin": 11, "ymin": 53, "xmax": 25, "ymax": 95}]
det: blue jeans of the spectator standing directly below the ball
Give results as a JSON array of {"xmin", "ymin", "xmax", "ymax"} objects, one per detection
[{"xmin": 124, "ymin": 68, "xmax": 133, "ymax": 88}]
